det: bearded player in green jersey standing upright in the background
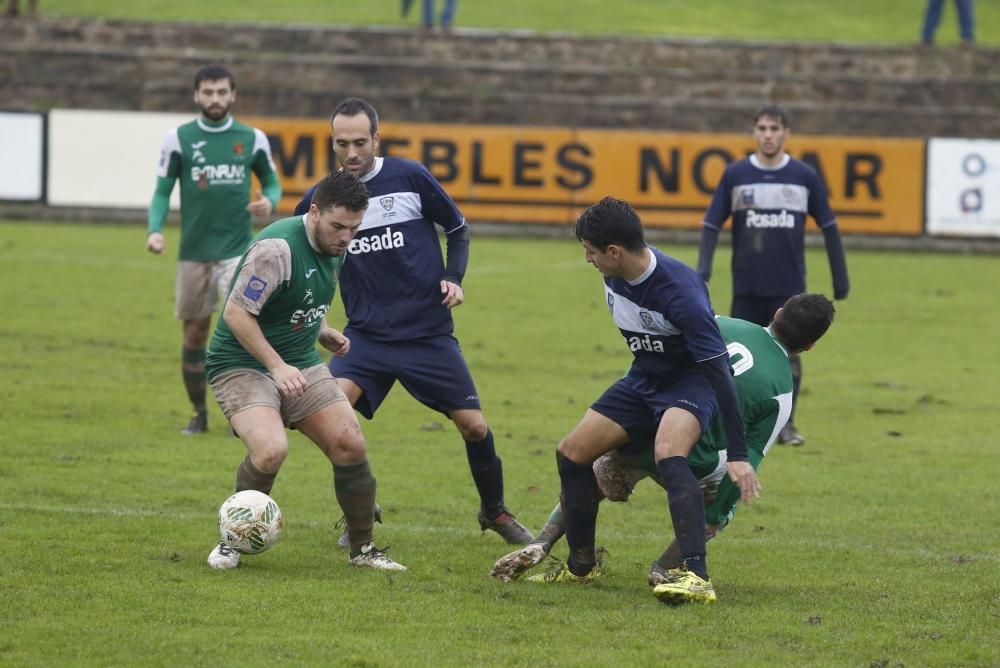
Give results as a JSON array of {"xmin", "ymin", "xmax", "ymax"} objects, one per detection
[{"xmin": 146, "ymin": 65, "xmax": 281, "ymax": 434}]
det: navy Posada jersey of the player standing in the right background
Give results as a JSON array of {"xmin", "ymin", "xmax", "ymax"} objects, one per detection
[{"xmin": 704, "ymin": 155, "xmax": 837, "ymax": 297}]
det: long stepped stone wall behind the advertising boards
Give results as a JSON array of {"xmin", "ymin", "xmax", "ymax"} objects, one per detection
[{"xmin": 0, "ymin": 18, "xmax": 1000, "ymax": 137}]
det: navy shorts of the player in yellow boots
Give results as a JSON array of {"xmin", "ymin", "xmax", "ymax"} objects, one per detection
[{"xmin": 591, "ymin": 366, "xmax": 718, "ymax": 441}]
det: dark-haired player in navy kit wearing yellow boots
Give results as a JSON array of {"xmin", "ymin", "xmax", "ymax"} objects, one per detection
[{"xmin": 541, "ymin": 197, "xmax": 760, "ymax": 603}]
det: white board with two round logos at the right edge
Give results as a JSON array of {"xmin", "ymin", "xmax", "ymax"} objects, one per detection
[{"xmin": 926, "ymin": 139, "xmax": 1000, "ymax": 237}]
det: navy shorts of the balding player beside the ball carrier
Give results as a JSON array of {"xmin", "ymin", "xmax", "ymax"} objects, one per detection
[{"xmin": 330, "ymin": 327, "xmax": 480, "ymax": 420}]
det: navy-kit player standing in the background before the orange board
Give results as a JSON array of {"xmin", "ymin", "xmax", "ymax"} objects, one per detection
[{"xmin": 698, "ymin": 105, "xmax": 850, "ymax": 445}]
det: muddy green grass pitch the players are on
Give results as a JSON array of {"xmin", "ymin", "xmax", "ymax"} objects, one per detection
[{"xmin": 0, "ymin": 222, "xmax": 1000, "ymax": 666}]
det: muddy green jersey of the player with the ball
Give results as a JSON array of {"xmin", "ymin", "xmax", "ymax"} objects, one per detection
[{"xmin": 205, "ymin": 214, "xmax": 343, "ymax": 380}]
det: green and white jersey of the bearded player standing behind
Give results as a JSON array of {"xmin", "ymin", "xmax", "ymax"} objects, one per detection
[{"xmin": 149, "ymin": 116, "xmax": 281, "ymax": 262}]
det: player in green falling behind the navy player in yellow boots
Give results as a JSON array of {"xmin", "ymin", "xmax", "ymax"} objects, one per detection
[{"xmin": 490, "ymin": 294, "xmax": 834, "ymax": 603}]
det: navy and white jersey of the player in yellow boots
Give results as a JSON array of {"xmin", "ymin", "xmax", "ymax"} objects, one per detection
[{"xmin": 604, "ymin": 246, "xmax": 727, "ymax": 379}]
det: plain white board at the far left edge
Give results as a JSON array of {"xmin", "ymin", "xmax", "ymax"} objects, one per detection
[{"xmin": 0, "ymin": 112, "xmax": 45, "ymax": 202}]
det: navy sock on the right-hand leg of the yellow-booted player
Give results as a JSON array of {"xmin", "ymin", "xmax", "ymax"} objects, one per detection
[{"xmin": 656, "ymin": 457, "xmax": 708, "ymax": 580}]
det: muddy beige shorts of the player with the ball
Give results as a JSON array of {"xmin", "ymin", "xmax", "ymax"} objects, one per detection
[{"xmin": 209, "ymin": 364, "xmax": 347, "ymax": 426}]
